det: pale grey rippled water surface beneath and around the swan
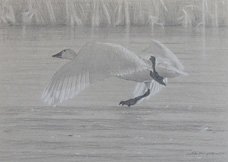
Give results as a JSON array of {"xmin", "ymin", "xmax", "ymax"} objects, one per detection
[{"xmin": 0, "ymin": 26, "xmax": 228, "ymax": 162}]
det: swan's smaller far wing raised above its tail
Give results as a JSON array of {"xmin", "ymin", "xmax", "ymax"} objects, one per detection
[{"xmin": 141, "ymin": 40, "xmax": 184, "ymax": 71}]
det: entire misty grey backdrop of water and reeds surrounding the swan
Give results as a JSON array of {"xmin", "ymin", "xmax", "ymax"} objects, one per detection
[{"xmin": 0, "ymin": 0, "xmax": 228, "ymax": 162}]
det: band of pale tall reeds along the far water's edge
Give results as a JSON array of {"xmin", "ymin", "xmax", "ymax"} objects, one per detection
[{"xmin": 0, "ymin": 0, "xmax": 228, "ymax": 28}]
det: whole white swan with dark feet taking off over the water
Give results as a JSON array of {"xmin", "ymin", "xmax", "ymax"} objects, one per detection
[{"xmin": 41, "ymin": 40, "xmax": 186, "ymax": 106}]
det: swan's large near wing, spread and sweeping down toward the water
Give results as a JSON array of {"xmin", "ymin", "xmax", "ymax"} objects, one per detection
[{"xmin": 42, "ymin": 42, "xmax": 147, "ymax": 105}]
